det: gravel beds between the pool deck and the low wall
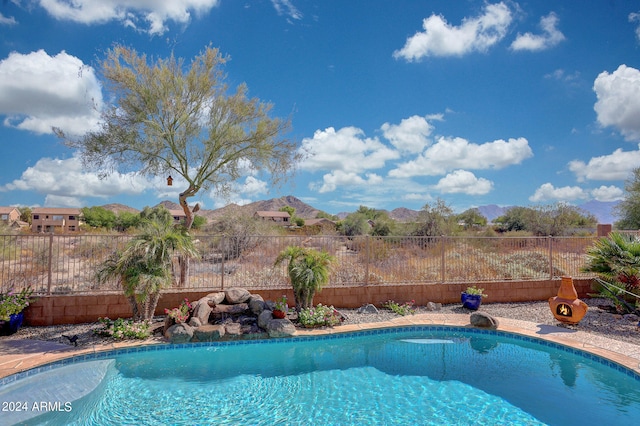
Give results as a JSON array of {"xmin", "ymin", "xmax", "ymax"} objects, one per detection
[{"xmin": 2, "ymin": 299, "xmax": 640, "ymax": 347}]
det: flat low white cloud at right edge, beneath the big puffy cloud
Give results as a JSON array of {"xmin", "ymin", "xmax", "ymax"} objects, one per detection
[{"xmin": 569, "ymin": 146, "xmax": 640, "ymax": 182}]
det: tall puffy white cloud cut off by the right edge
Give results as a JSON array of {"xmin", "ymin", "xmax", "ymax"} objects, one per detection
[{"xmin": 593, "ymin": 65, "xmax": 640, "ymax": 140}]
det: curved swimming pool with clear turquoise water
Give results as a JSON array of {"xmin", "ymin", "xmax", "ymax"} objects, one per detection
[{"xmin": 0, "ymin": 326, "xmax": 640, "ymax": 425}]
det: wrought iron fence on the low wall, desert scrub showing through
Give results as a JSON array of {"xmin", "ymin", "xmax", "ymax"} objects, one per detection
[{"xmin": 0, "ymin": 234, "xmax": 595, "ymax": 294}]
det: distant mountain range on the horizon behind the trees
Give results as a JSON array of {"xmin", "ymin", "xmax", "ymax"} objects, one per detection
[{"xmin": 102, "ymin": 195, "xmax": 618, "ymax": 224}]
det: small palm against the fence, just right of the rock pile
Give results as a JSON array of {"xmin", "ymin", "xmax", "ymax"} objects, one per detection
[{"xmin": 275, "ymin": 246, "xmax": 334, "ymax": 311}]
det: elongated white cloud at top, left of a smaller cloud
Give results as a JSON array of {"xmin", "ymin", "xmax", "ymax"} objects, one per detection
[{"xmin": 393, "ymin": 2, "xmax": 512, "ymax": 61}]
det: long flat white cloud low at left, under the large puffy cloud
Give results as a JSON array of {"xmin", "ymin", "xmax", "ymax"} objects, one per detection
[{"xmin": 0, "ymin": 156, "xmax": 148, "ymax": 203}]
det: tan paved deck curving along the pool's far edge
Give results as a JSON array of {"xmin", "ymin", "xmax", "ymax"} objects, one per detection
[{"xmin": 0, "ymin": 314, "xmax": 640, "ymax": 378}]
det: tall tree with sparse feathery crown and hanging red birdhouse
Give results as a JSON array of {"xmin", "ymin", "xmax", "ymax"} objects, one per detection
[{"xmin": 54, "ymin": 45, "xmax": 298, "ymax": 230}]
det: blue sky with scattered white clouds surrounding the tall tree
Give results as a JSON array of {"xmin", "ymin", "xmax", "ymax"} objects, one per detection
[{"xmin": 0, "ymin": 0, "xmax": 640, "ymax": 213}]
